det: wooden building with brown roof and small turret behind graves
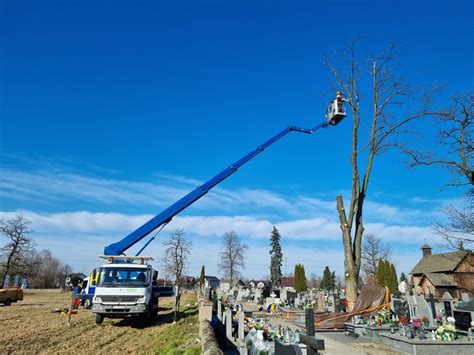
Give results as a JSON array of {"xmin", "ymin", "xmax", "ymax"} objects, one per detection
[{"xmin": 410, "ymin": 244, "xmax": 474, "ymax": 300}]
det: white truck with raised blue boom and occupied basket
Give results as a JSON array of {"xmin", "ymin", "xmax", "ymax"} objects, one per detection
[{"xmin": 89, "ymin": 92, "xmax": 346, "ymax": 324}]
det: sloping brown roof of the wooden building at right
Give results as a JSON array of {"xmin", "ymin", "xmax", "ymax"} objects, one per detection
[{"xmin": 411, "ymin": 250, "xmax": 471, "ymax": 275}]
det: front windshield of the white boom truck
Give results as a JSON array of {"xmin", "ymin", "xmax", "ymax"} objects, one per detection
[{"xmin": 98, "ymin": 267, "xmax": 147, "ymax": 287}]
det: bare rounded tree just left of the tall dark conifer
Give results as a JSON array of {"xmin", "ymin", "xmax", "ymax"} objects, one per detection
[{"xmin": 219, "ymin": 231, "xmax": 248, "ymax": 287}]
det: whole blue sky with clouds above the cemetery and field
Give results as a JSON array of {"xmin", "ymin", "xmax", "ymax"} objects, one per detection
[{"xmin": 0, "ymin": 1, "xmax": 474, "ymax": 277}]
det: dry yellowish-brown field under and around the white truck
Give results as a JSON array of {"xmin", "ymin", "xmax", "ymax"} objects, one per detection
[{"xmin": 0, "ymin": 291, "xmax": 200, "ymax": 354}]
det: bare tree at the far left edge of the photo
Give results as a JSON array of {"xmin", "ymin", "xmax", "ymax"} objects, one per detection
[{"xmin": 0, "ymin": 215, "xmax": 35, "ymax": 285}]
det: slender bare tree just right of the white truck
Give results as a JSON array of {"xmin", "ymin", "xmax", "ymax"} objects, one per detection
[{"xmin": 162, "ymin": 229, "xmax": 192, "ymax": 322}]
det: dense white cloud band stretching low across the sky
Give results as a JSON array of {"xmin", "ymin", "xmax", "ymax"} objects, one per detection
[{"xmin": 0, "ymin": 211, "xmax": 439, "ymax": 244}]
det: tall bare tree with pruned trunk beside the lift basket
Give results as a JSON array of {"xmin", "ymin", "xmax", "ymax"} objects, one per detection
[{"xmin": 325, "ymin": 42, "xmax": 440, "ymax": 310}]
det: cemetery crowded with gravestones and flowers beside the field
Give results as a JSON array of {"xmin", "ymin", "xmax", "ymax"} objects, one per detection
[{"xmin": 194, "ymin": 246, "xmax": 474, "ymax": 354}]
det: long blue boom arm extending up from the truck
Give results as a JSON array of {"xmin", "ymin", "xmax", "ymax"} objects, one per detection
[{"xmin": 104, "ymin": 121, "xmax": 335, "ymax": 255}]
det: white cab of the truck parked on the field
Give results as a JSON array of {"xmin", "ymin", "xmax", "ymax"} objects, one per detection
[{"xmin": 92, "ymin": 256, "xmax": 159, "ymax": 324}]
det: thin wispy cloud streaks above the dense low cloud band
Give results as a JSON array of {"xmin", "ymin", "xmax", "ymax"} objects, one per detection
[{"xmin": 0, "ymin": 158, "xmax": 452, "ymax": 224}]
